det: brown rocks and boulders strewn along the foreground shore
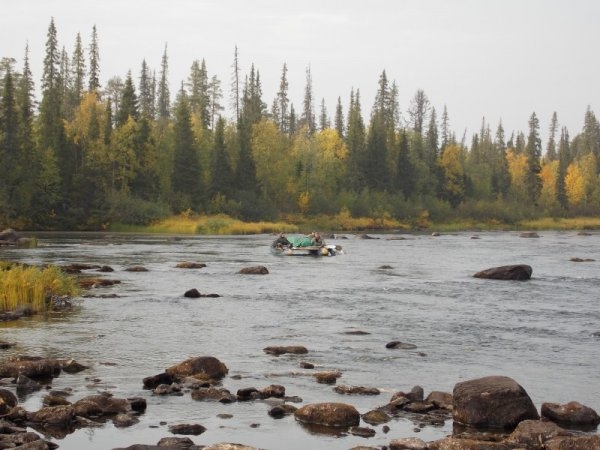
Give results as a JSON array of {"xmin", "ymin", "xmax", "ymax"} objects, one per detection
[{"xmin": 0, "ymin": 352, "xmax": 600, "ymax": 450}]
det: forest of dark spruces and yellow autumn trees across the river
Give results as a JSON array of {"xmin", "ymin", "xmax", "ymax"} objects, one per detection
[{"xmin": 0, "ymin": 19, "xmax": 600, "ymax": 230}]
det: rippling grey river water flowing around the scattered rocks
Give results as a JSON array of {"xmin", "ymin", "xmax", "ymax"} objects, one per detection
[{"xmin": 0, "ymin": 232, "xmax": 600, "ymax": 450}]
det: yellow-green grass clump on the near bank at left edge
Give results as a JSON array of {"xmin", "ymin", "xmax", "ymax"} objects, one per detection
[{"xmin": 0, "ymin": 261, "xmax": 80, "ymax": 313}]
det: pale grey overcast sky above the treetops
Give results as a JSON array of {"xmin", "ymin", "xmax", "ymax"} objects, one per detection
[{"xmin": 0, "ymin": 0, "xmax": 600, "ymax": 143}]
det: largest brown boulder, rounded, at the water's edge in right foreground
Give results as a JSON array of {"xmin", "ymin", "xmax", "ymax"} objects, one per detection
[{"xmin": 452, "ymin": 376, "xmax": 540, "ymax": 429}]
